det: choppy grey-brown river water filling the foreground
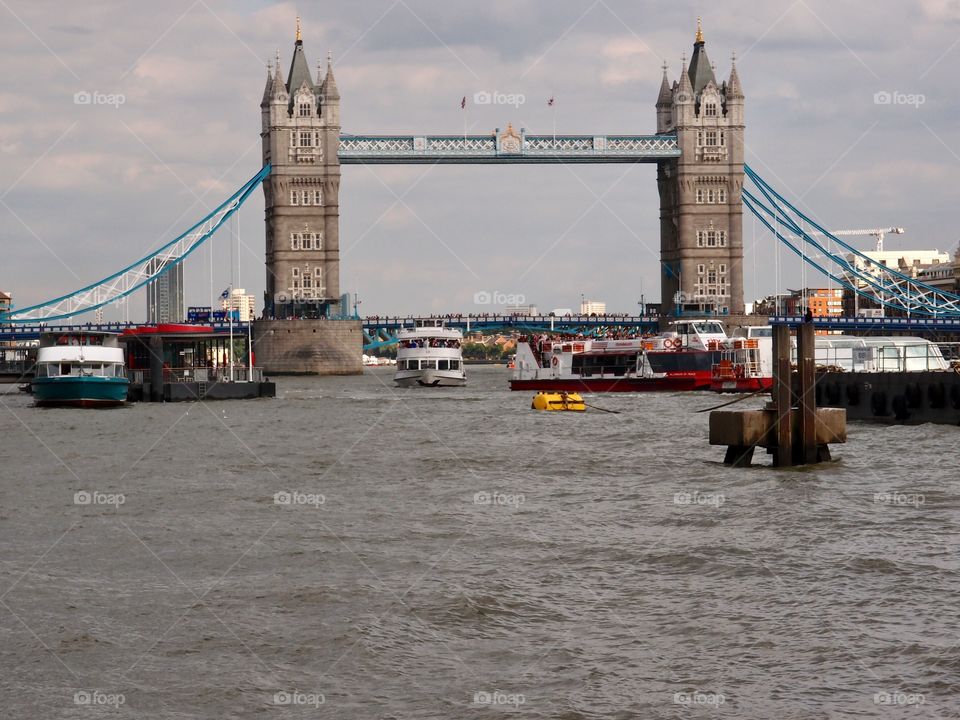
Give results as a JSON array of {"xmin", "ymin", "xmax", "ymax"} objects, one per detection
[{"xmin": 0, "ymin": 367, "xmax": 960, "ymax": 720}]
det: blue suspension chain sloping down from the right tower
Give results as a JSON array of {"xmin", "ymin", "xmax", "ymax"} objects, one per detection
[{"xmin": 743, "ymin": 165, "xmax": 960, "ymax": 317}]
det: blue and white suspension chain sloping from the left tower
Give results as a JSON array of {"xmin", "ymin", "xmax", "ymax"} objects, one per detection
[{"xmin": 0, "ymin": 163, "xmax": 270, "ymax": 323}]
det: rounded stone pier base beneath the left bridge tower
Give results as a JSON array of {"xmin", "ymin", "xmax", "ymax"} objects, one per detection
[{"xmin": 253, "ymin": 319, "xmax": 363, "ymax": 375}]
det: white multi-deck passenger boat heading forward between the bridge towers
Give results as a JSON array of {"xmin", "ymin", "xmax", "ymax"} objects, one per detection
[{"xmin": 393, "ymin": 319, "xmax": 467, "ymax": 387}]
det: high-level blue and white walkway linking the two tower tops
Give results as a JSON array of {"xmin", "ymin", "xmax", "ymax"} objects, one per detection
[{"xmin": 337, "ymin": 133, "xmax": 680, "ymax": 165}]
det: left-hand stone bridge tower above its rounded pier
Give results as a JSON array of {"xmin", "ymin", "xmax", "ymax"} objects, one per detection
[{"xmin": 260, "ymin": 18, "xmax": 340, "ymax": 319}]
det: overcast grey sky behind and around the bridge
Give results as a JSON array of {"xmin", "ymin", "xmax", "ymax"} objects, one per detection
[{"xmin": 0, "ymin": 0, "xmax": 960, "ymax": 320}]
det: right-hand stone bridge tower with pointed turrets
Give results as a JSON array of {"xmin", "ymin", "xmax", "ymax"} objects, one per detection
[{"xmin": 656, "ymin": 20, "xmax": 744, "ymax": 314}]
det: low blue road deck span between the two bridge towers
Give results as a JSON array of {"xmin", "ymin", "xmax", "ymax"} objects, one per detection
[{"xmin": 363, "ymin": 315, "xmax": 659, "ymax": 351}]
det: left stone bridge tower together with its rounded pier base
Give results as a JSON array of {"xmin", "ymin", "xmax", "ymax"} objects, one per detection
[{"xmin": 253, "ymin": 18, "xmax": 363, "ymax": 375}]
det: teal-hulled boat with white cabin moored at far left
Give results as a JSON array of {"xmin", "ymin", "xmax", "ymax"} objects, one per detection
[{"xmin": 30, "ymin": 331, "xmax": 130, "ymax": 407}]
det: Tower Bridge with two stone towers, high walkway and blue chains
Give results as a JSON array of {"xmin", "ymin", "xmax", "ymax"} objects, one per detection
[{"xmin": 18, "ymin": 21, "xmax": 960, "ymax": 374}]
